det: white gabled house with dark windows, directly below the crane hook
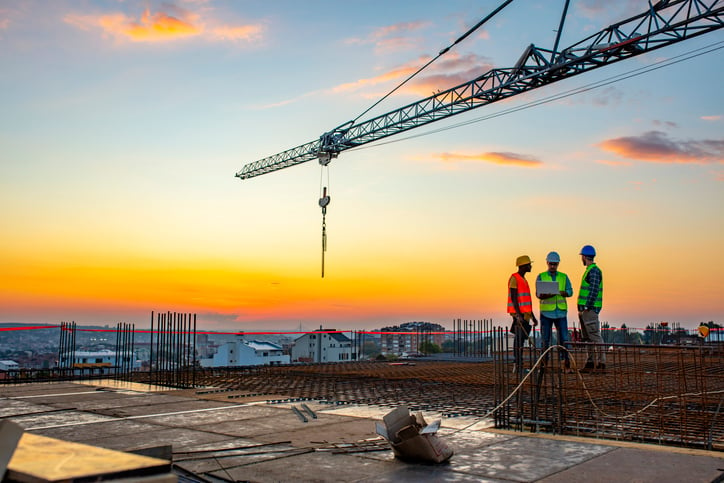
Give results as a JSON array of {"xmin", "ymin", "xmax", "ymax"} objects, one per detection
[{"xmin": 292, "ymin": 327, "xmax": 358, "ymax": 362}]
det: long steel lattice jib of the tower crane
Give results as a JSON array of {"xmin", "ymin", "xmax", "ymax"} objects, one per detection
[{"xmin": 236, "ymin": 0, "xmax": 724, "ymax": 179}]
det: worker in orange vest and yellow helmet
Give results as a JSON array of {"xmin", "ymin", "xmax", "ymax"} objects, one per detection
[{"xmin": 508, "ymin": 255, "xmax": 538, "ymax": 375}]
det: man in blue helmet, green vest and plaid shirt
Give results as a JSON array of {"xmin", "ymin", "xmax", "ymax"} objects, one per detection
[{"xmin": 578, "ymin": 245, "xmax": 606, "ymax": 372}]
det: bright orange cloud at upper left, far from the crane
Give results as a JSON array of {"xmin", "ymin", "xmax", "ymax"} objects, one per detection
[{"xmin": 64, "ymin": 4, "xmax": 264, "ymax": 42}]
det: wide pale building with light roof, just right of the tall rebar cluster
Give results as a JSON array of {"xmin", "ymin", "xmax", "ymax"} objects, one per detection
[{"xmin": 200, "ymin": 336, "xmax": 289, "ymax": 367}]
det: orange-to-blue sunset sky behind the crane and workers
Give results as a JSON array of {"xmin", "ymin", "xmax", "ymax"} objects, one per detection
[{"xmin": 0, "ymin": 0, "xmax": 724, "ymax": 330}]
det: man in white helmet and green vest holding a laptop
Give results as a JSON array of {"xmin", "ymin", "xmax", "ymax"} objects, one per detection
[{"xmin": 536, "ymin": 252, "xmax": 573, "ymax": 369}]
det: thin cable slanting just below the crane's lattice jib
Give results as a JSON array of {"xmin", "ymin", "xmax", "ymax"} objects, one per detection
[{"xmin": 349, "ymin": 41, "xmax": 724, "ymax": 152}]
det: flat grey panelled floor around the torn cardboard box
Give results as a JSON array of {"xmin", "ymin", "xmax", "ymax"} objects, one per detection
[{"xmin": 0, "ymin": 381, "xmax": 724, "ymax": 482}]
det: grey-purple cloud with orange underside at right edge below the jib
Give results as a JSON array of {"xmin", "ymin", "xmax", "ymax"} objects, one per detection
[{"xmin": 598, "ymin": 131, "xmax": 724, "ymax": 163}]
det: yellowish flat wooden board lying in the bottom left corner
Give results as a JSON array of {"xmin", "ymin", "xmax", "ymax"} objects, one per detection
[{"xmin": 6, "ymin": 433, "xmax": 171, "ymax": 483}]
